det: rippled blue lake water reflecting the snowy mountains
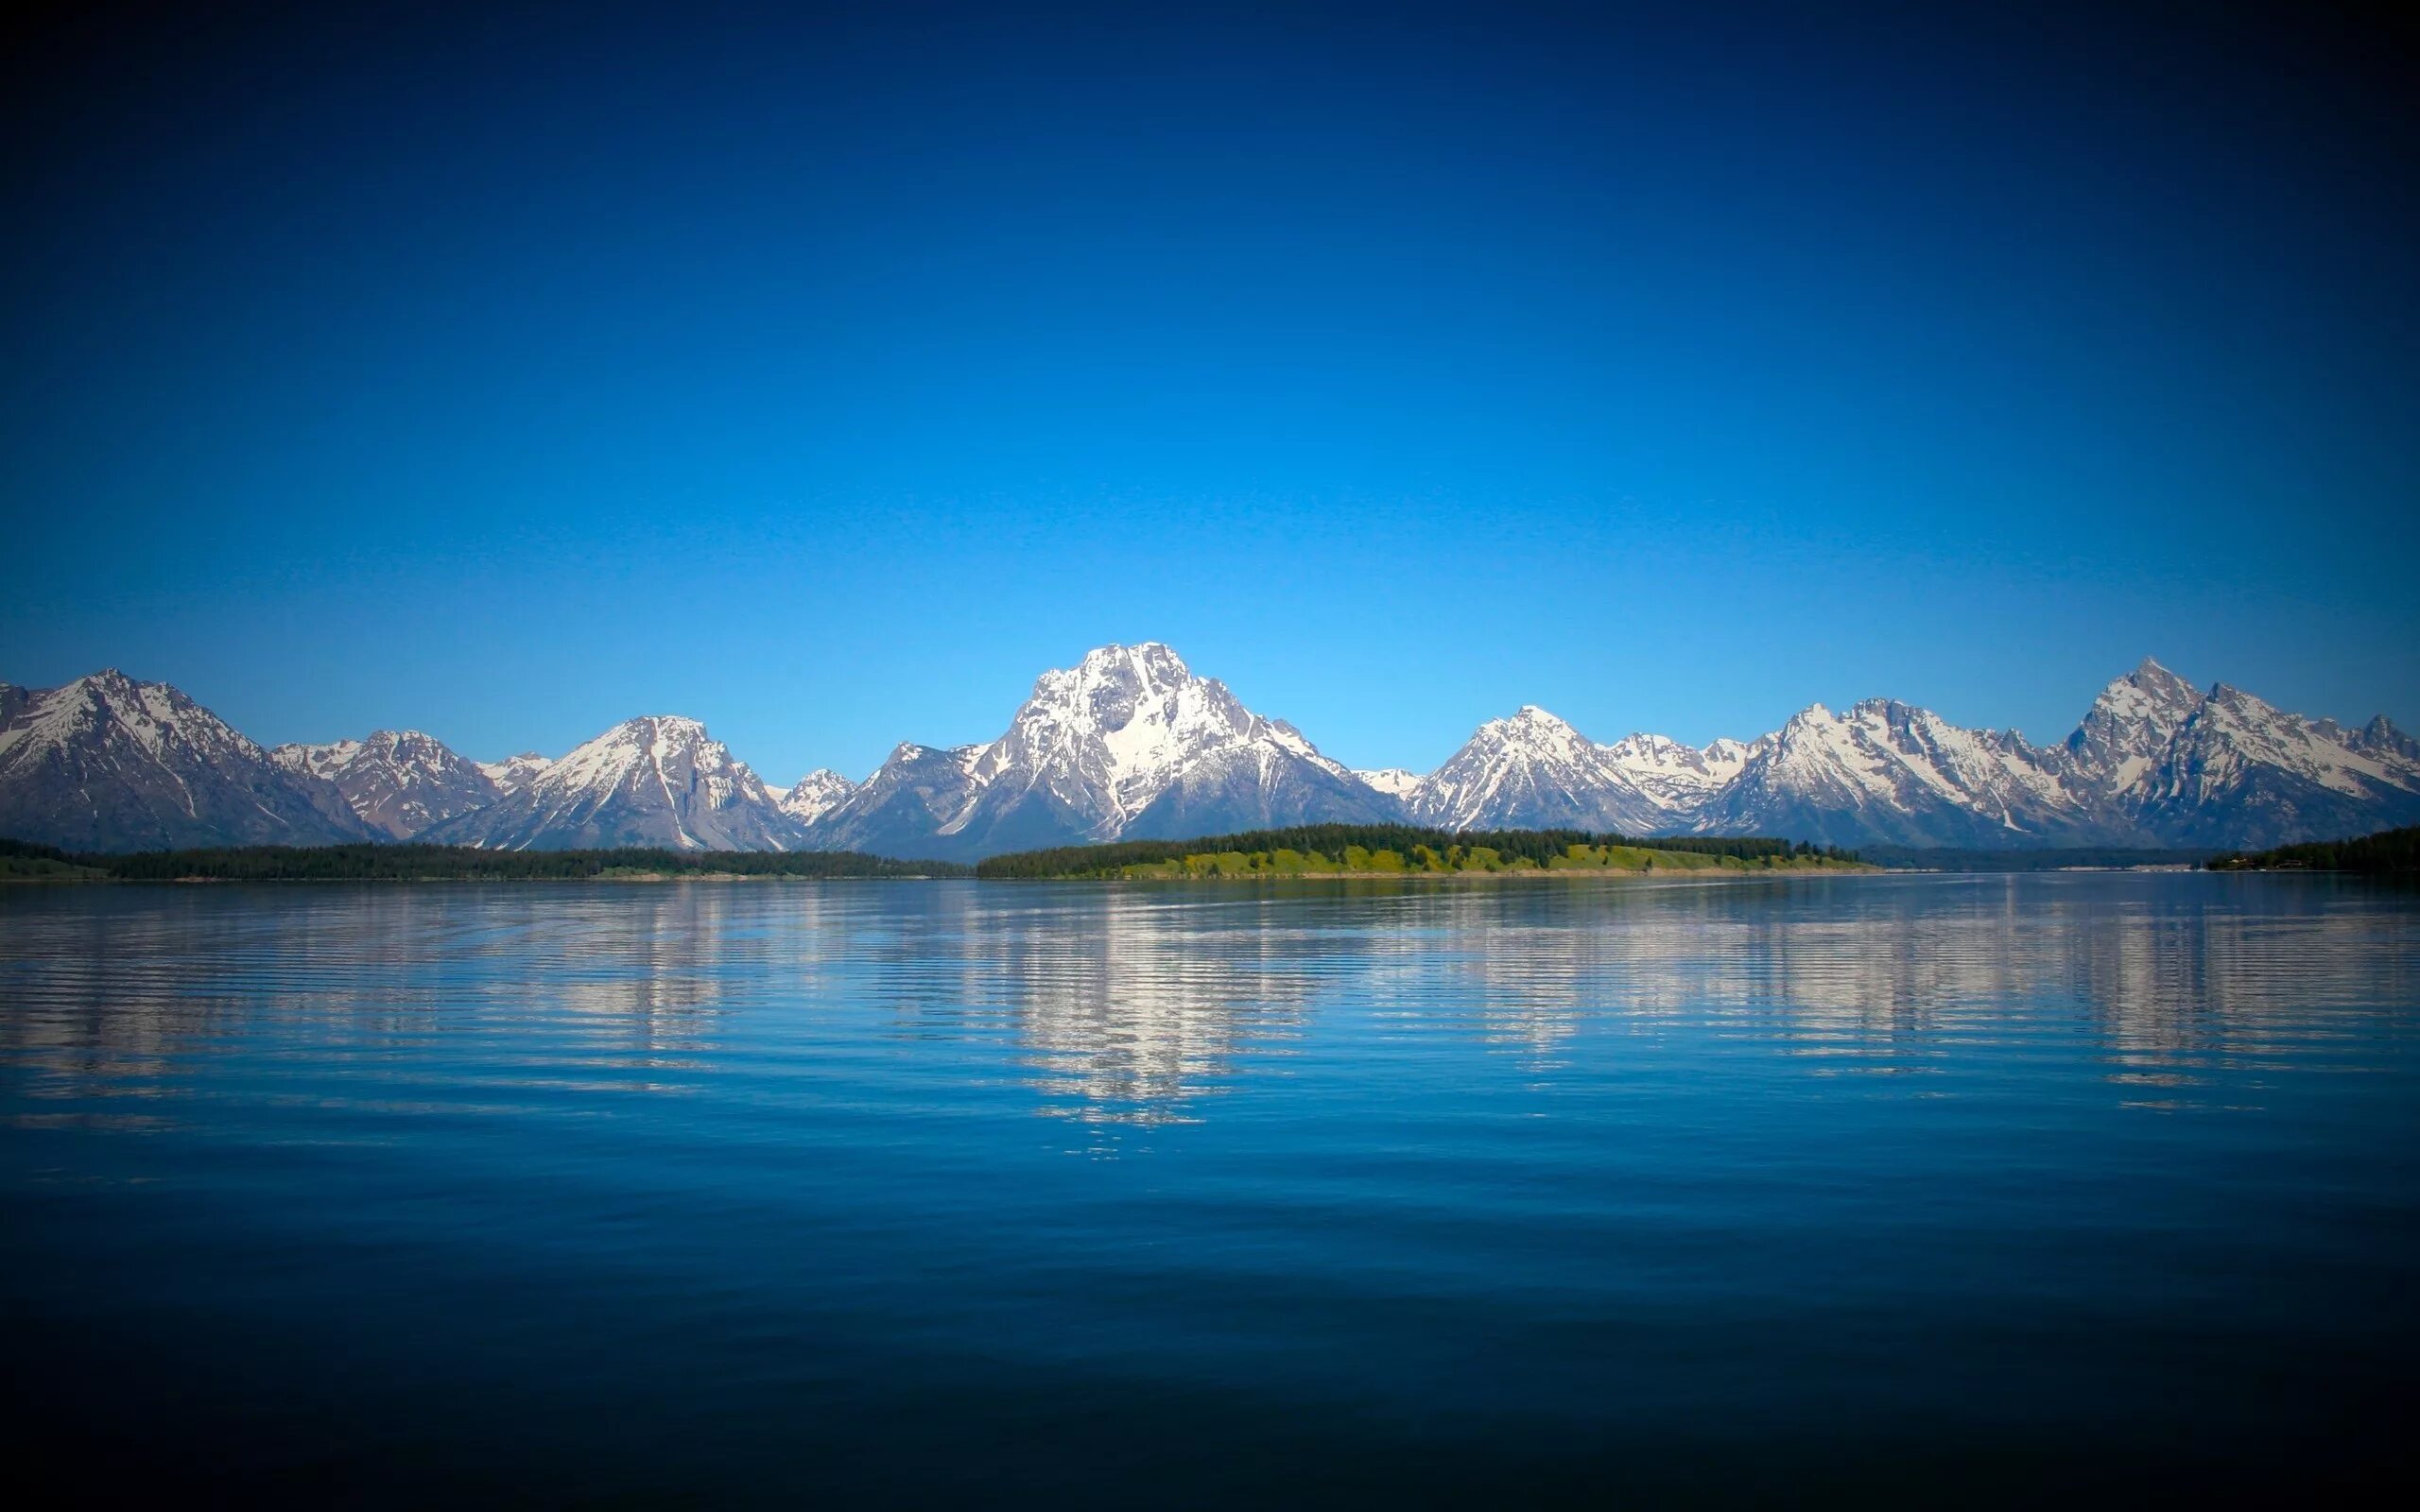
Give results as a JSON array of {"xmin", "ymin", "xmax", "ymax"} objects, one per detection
[{"xmin": 0, "ymin": 873, "xmax": 2420, "ymax": 1504}]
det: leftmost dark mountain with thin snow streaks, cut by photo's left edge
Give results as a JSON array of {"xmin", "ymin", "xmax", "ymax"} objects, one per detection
[{"xmin": 0, "ymin": 668, "xmax": 368, "ymax": 851}]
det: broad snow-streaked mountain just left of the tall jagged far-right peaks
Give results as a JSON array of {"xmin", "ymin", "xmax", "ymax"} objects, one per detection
[{"xmin": 1691, "ymin": 699, "xmax": 2105, "ymax": 847}]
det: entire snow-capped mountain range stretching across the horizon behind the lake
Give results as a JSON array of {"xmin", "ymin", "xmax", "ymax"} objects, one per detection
[{"xmin": 0, "ymin": 644, "xmax": 2420, "ymax": 859}]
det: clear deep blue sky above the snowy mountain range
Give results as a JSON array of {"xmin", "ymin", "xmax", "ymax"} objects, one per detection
[{"xmin": 0, "ymin": 5, "xmax": 2420, "ymax": 782}]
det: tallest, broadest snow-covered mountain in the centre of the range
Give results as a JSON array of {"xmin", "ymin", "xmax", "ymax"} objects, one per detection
[{"xmin": 811, "ymin": 641, "xmax": 1401, "ymax": 859}]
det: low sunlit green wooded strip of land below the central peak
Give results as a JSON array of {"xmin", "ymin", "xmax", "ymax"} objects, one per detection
[{"xmin": 976, "ymin": 825, "xmax": 1873, "ymax": 881}]
